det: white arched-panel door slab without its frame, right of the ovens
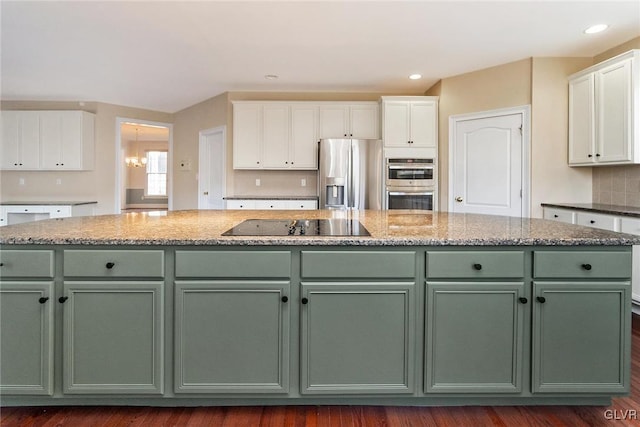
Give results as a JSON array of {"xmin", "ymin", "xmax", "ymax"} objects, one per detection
[{"xmin": 450, "ymin": 114, "xmax": 523, "ymax": 217}]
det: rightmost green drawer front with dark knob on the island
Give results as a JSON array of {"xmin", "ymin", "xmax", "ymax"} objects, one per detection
[{"xmin": 533, "ymin": 251, "xmax": 631, "ymax": 279}]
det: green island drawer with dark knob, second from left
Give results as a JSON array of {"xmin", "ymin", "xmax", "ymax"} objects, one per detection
[{"xmin": 64, "ymin": 250, "xmax": 164, "ymax": 278}]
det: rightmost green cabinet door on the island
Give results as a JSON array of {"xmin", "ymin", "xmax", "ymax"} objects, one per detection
[{"xmin": 533, "ymin": 281, "xmax": 631, "ymax": 393}]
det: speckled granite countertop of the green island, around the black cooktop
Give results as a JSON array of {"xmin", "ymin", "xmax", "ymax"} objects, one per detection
[{"xmin": 0, "ymin": 210, "xmax": 640, "ymax": 246}]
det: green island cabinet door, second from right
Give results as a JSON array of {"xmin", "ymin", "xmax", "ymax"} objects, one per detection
[{"xmin": 425, "ymin": 282, "xmax": 530, "ymax": 393}]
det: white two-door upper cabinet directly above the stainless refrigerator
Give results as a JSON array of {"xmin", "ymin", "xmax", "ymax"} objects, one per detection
[{"xmin": 320, "ymin": 102, "xmax": 380, "ymax": 139}]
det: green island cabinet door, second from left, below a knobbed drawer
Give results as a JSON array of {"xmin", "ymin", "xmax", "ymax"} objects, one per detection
[{"xmin": 59, "ymin": 281, "xmax": 164, "ymax": 394}]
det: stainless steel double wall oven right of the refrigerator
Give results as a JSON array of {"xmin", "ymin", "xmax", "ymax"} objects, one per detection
[{"xmin": 385, "ymin": 158, "xmax": 436, "ymax": 210}]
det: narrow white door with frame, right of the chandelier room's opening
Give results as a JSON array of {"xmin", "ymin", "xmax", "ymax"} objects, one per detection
[{"xmin": 198, "ymin": 126, "xmax": 227, "ymax": 209}]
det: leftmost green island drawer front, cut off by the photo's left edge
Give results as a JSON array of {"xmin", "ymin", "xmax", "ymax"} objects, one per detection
[{"xmin": 0, "ymin": 250, "xmax": 53, "ymax": 279}]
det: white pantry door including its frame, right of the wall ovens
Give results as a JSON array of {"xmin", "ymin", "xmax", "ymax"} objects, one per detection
[{"xmin": 448, "ymin": 106, "xmax": 530, "ymax": 217}]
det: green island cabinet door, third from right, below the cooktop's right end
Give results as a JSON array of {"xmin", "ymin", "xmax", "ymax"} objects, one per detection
[{"xmin": 300, "ymin": 282, "xmax": 415, "ymax": 394}]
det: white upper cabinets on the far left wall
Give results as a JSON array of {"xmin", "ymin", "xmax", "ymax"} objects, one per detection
[{"xmin": 1, "ymin": 111, "xmax": 95, "ymax": 170}]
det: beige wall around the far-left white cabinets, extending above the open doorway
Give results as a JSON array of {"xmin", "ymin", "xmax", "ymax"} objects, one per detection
[{"xmin": 0, "ymin": 101, "xmax": 172, "ymax": 215}]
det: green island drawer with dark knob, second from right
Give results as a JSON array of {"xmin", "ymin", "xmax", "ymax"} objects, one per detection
[{"xmin": 427, "ymin": 251, "xmax": 524, "ymax": 279}]
